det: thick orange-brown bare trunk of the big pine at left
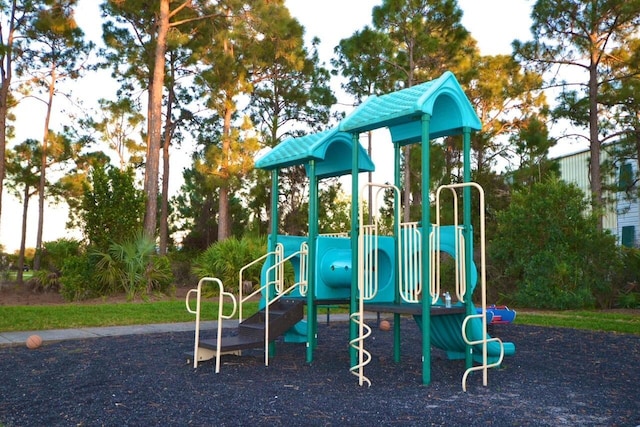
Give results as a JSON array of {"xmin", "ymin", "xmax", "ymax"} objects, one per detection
[{"xmin": 144, "ymin": 0, "xmax": 169, "ymax": 239}]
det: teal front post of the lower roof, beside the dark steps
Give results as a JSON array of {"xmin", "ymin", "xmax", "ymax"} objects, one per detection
[{"xmin": 307, "ymin": 159, "xmax": 318, "ymax": 363}]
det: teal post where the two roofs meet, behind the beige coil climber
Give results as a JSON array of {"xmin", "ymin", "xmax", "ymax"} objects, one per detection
[{"xmin": 349, "ymin": 133, "xmax": 360, "ymax": 366}]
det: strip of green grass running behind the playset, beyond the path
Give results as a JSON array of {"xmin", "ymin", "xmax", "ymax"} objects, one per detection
[{"xmin": 0, "ymin": 300, "xmax": 640, "ymax": 335}]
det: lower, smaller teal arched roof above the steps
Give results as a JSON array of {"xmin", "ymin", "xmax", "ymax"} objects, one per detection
[{"xmin": 255, "ymin": 128, "xmax": 375, "ymax": 178}]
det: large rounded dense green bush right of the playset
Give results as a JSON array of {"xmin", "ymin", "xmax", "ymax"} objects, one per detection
[{"xmin": 490, "ymin": 179, "xmax": 622, "ymax": 309}]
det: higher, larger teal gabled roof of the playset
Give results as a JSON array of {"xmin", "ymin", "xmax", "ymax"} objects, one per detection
[{"xmin": 339, "ymin": 71, "xmax": 482, "ymax": 144}]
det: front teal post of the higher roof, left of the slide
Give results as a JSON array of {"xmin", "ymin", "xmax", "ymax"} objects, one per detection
[{"xmin": 420, "ymin": 114, "xmax": 431, "ymax": 385}]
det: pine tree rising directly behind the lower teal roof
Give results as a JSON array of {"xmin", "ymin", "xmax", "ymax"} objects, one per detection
[{"xmin": 249, "ymin": 25, "xmax": 336, "ymax": 233}]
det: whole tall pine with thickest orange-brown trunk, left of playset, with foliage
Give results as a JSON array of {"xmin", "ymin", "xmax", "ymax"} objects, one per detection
[{"xmin": 102, "ymin": 0, "xmax": 202, "ymax": 246}]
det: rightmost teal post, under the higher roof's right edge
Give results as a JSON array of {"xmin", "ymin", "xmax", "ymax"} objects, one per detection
[{"xmin": 462, "ymin": 127, "xmax": 475, "ymax": 369}]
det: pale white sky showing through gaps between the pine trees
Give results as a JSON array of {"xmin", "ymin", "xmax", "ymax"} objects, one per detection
[{"xmin": 0, "ymin": 0, "xmax": 534, "ymax": 252}]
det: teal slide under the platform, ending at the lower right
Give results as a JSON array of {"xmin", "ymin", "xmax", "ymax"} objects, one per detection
[{"xmin": 414, "ymin": 313, "xmax": 516, "ymax": 363}]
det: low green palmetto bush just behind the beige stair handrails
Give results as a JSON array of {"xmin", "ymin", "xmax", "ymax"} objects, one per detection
[{"xmin": 193, "ymin": 237, "xmax": 267, "ymax": 292}]
